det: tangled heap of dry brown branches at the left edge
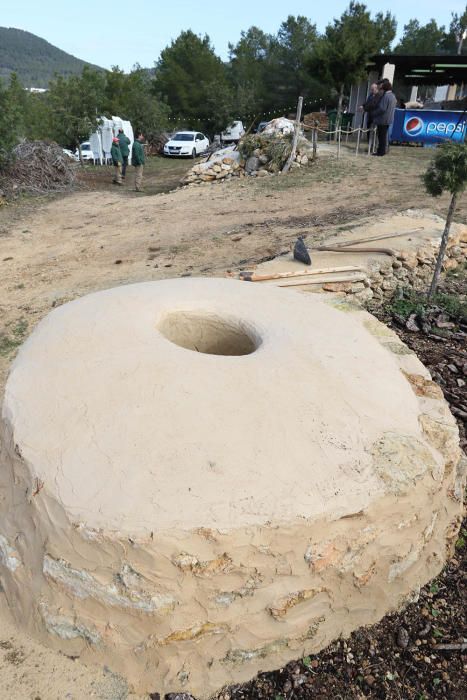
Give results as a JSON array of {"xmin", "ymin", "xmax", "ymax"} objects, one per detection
[{"xmin": 0, "ymin": 141, "xmax": 77, "ymax": 195}]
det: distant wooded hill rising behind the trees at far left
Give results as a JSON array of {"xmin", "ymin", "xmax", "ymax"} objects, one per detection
[{"xmin": 0, "ymin": 27, "xmax": 99, "ymax": 88}]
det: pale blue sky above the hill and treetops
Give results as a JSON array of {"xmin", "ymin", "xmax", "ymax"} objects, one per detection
[{"xmin": 0, "ymin": 0, "xmax": 466, "ymax": 71}]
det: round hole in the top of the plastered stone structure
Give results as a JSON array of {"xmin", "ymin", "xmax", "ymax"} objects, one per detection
[{"xmin": 157, "ymin": 311, "xmax": 261, "ymax": 356}]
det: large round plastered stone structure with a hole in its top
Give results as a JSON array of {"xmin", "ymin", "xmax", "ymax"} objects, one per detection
[{"xmin": 0, "ymin": 279, "xmax": 463, "ymax": 698}]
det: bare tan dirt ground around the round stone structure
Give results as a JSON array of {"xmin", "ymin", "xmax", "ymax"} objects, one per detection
[{"xmin": 0, "ymin": 148, "xmax": 467, "ymax": 700}]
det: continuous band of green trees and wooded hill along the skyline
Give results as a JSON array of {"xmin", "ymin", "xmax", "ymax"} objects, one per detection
[{"xmin": 0, "ymin": 0, "xmax": 467, "ymax": 170}]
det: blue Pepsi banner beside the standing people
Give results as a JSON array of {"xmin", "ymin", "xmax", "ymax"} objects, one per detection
[{"xmin": 390, "ymin": 109, "xmax": 467, "ymax": 145}]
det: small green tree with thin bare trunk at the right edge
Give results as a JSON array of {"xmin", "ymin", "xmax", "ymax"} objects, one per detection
[{"xmin": 423, "ymin": 141, "xmax": 467, "ymax": 299}]
